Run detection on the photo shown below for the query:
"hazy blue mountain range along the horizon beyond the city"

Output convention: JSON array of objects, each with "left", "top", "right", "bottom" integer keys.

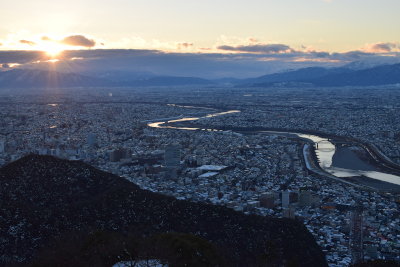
[{"left": 0, "top": 62, "right": 400, "bottom": 88}]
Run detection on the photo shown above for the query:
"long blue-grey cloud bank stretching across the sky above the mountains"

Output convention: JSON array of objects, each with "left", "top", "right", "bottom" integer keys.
[{"left": 0, "top": 45, "right": 400, "bottom": 78}]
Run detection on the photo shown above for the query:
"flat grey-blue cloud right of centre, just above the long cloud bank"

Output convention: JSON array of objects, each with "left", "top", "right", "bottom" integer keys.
[{"left": 217, "top": 44, "right": 295, "bottom": 54}]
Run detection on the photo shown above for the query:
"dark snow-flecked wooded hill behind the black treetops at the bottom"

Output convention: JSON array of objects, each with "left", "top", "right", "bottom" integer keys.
[{"left": 0, "top": 155, "right": 326, "bottom": 266}]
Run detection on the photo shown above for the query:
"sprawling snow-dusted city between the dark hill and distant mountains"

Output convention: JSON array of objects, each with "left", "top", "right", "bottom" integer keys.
[{"left": 0, "top": 86, "right": 400, "bottom": 266}]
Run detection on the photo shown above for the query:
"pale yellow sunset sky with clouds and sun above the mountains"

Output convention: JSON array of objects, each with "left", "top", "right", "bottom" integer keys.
[{"left": 0, "top": 0, "right": 400, "bottom": 78}]
